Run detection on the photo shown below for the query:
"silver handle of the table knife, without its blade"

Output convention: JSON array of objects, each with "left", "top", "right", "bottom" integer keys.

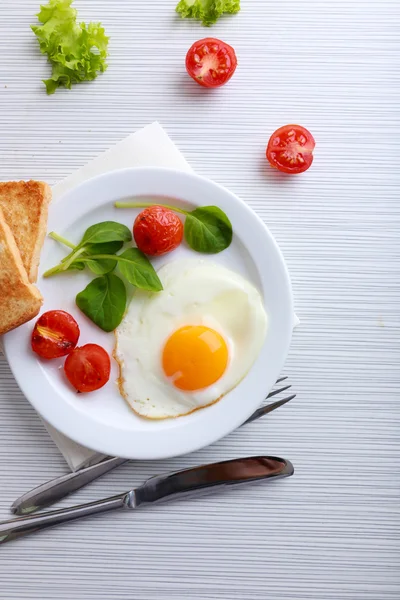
[{"left": 0, "top": 494, "right": 126, "bottom": 544}]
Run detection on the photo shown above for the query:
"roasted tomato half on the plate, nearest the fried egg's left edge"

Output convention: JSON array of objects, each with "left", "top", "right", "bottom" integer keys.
[{"left": 64, "top": 344, "right": 111, "bottom": 392}]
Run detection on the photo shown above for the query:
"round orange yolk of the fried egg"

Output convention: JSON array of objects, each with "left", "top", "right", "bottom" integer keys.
[{"left": 162, "top": 325, "right": 228, "bottom": 392}]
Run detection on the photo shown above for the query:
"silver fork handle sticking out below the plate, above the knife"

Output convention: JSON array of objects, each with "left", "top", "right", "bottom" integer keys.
[{"left": 11, "top": 458, "right": 127, "bottom": 515}]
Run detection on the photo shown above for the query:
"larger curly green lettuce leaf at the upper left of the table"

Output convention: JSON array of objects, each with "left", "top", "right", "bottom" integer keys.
[{"left": 31, "top": 0, "right": 108, "bottom": 94}]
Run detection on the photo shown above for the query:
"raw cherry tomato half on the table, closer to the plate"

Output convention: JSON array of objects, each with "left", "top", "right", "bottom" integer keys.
[{"left": 267, "top": 125, "right": 315, "bottom": 174}]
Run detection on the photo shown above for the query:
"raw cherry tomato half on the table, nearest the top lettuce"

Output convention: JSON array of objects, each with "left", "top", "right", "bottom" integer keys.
[{"left": 186, "top": 38, "right": 237, "bottom": 87}]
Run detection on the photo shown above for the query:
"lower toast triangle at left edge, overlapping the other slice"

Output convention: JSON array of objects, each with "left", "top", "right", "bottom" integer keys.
[{"left": 0, "top": 208, "right": 43, "bottom": 335}]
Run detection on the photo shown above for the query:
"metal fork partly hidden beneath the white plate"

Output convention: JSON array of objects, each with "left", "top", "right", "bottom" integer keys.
[{"left": 11, "top": 377, "right": 296, "bottom": 515}]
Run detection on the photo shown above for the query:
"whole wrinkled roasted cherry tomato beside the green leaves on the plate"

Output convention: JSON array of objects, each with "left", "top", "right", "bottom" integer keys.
[{"left": 133, "top": 205, "right": 183, "bottom": 256}]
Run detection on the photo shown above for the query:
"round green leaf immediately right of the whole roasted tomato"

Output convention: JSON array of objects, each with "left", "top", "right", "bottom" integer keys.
[{"left": 185, "top": 206, "right": 232, "bottom": 254}]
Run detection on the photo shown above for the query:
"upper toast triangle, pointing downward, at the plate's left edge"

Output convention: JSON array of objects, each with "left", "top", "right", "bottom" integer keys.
[{"left": 0, "top": 181, "right": 51, "bottom": 282}]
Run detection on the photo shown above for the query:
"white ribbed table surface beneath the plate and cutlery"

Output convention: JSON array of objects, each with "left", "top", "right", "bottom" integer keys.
[{"left": 0, "top": 0, "right": 400, "bottom": 600}]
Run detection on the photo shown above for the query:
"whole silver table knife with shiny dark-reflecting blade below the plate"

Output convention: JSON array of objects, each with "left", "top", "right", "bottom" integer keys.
[{"left": 0, "top": 456, "right": 294, "bottom": 544}]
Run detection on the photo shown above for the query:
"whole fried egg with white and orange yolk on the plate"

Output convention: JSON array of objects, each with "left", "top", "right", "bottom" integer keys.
[{"left": 114, "top": 259, "right": 268, "bottom": 419}]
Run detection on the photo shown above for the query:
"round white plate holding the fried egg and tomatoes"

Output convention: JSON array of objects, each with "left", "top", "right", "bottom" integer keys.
[{"left": 4, "top": 168, "right": 293, "bottom": 459}]
